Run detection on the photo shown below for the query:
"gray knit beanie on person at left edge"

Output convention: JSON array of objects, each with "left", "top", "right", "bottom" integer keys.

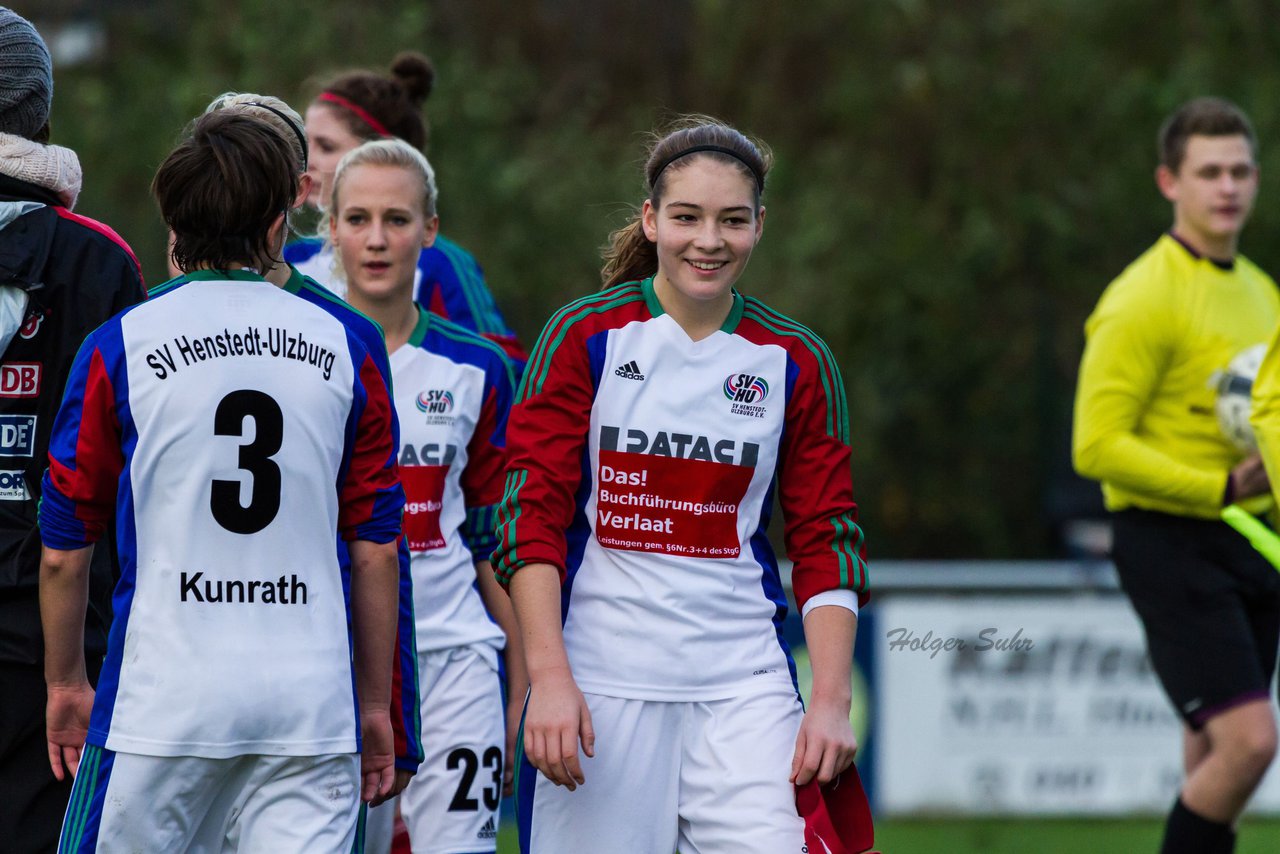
[{"left": 0, "top": 6, "right": 54, "bottom": 140}]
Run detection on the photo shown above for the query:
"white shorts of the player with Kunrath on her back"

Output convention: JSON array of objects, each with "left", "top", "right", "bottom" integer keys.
[{"left": 58, "top": 745, "right": 360, "bottom": 854}]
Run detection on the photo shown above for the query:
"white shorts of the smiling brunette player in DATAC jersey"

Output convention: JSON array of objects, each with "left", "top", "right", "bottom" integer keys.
[{"left": 516, "top": 693, "right": 805, "bottom": 854}]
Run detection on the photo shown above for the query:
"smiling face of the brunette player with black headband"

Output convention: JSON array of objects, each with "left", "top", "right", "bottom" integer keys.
[{"left": 641, "top": 155, "right": 764, "bottom": 311}]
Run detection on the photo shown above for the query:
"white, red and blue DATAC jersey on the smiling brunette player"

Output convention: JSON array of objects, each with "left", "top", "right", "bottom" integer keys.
[{"left": 494, "top": 280, "right": 867, "bottom": 700}]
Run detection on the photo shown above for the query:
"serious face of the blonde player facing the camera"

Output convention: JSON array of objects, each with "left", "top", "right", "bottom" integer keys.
[{"left": 329, "top": 164, "right": 439, "bottom": 301}]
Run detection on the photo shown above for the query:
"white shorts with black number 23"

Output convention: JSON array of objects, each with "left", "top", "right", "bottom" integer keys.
[{"left": 401, "top": 647, "right": 507, "bottom": 854}]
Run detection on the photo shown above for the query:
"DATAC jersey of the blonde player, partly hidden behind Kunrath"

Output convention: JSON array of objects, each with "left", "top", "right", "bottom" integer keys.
[{"left": 390, "top": 309, "right": 515, "bottom": 661}]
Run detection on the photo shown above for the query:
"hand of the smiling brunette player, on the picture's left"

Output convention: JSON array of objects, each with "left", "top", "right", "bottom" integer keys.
[{"left": 525, "top": 668, "right": 595, "bottom": 791}]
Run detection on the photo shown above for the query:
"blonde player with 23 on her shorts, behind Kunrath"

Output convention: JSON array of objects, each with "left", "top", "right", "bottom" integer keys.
[{"left": 328, "top": 140, "right": 526, "bottom": 854}]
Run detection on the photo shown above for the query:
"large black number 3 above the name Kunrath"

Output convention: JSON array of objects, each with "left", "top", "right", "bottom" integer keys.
[{"left": 209, "top": 388, "right": 284, "bottom": 534}]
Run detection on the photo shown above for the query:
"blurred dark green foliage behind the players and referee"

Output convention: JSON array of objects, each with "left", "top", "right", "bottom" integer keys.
[{"left": 40, "top": 0, "right": 1280, "bottom": 557}]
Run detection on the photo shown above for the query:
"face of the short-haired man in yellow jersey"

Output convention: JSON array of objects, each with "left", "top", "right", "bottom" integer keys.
[{"left": 1157, "top": 134, "right": 1258, "bottom": 259}]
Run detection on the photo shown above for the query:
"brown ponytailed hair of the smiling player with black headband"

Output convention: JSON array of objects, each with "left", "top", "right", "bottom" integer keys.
[{"left": 600, "top": 115, "right": 773, "bottom": 288}]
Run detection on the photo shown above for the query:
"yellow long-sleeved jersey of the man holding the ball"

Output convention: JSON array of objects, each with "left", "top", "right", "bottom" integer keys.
[{"left": 1071, "top": 234, "right": 1280, "bottom": 519}]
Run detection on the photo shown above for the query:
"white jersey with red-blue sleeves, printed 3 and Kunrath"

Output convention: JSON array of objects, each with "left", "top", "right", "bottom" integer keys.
[{"left": 40, "top": 271, "right": 403, "bottom": 758}]
